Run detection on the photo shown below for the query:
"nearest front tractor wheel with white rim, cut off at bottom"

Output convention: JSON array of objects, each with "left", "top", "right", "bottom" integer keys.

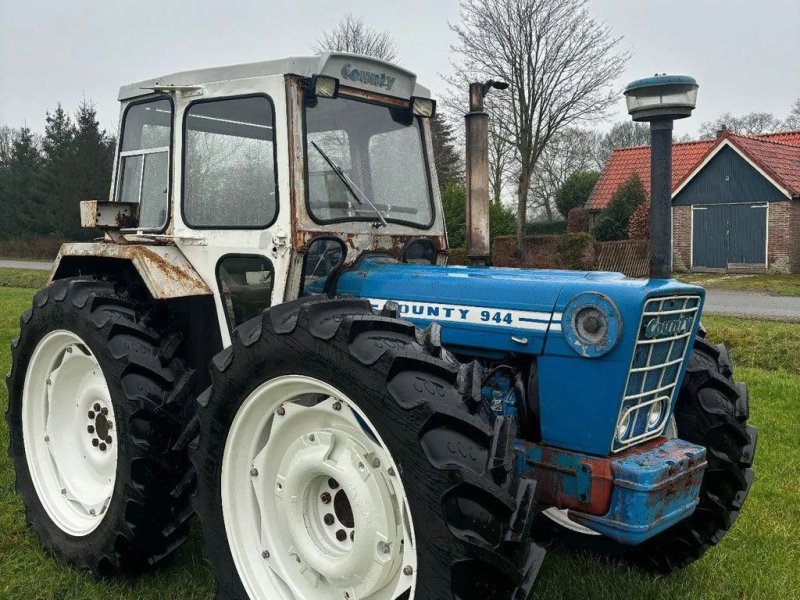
[{"left": 193, "top": 298, "right": 541, "bottom": 600}]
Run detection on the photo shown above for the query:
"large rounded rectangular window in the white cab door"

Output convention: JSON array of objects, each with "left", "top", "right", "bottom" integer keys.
[{"left": 183, "top": 97, "right": 277, "bottom": 229}]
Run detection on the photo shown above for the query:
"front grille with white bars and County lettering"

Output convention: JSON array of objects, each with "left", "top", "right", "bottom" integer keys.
[{"left": 611, "top": 296, "right": 700, "bottom": 452}]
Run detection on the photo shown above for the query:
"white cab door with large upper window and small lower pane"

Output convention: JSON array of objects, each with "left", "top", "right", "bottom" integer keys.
[{"left": 173, "top": 76, "right": 291, "bottom": 345}]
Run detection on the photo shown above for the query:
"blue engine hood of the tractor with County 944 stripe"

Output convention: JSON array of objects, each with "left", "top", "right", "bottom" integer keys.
[{"left": 337, "top": 256, "right": 705, "bottom": 456}]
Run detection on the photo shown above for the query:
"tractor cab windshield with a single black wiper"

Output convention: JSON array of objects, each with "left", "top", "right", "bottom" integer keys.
[{"left": 306, "top": 97, "right": 433, "bottom": 228}]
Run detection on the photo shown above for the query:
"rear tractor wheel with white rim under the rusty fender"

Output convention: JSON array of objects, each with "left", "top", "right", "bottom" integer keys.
[{"left": 6, "top": 278, "right": 193, "bottom": 576}]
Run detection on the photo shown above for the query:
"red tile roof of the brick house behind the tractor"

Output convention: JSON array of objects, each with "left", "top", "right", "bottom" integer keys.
[{"left": 586, "top": 131, "right": 800, "bottom": 210}]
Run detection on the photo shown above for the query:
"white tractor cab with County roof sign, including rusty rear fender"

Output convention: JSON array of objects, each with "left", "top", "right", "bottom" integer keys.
[{"left": 54, "top": 53, "right": 447, "bottom": 346}]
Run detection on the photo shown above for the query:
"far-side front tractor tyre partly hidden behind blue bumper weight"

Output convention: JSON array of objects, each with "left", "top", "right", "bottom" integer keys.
[{"left": 535, "top": 331, "right": 757, "bottom": 573}]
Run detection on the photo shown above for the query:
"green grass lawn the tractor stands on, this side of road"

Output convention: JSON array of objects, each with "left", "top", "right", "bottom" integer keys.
[{"left": 0, "top": 287, "right": 800, "bottom": 600}]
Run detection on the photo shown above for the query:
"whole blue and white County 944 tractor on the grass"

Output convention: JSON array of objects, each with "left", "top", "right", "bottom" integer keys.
[{"left": 6, "top": 53, "right": 756, "bottom": 600}]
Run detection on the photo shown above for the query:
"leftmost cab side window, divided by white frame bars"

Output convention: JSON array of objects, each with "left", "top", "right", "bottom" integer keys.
[{"left": 117, "top": 99, "right": 172, "bottom": 229}]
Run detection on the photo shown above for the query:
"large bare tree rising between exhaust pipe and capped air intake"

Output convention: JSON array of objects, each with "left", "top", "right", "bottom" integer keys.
[{"left": 451, "top": 0, "right": 628, "bottom": 248}]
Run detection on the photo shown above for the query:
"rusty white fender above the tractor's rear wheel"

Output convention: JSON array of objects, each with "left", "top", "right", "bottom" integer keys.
[{"left": 50, "top": 242, "right": 212, "bottom": 300}]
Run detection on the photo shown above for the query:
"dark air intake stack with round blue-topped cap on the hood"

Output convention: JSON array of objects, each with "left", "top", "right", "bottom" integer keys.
[{"left": 625, "top": 75, "right": 699, "bottom": 279}]
